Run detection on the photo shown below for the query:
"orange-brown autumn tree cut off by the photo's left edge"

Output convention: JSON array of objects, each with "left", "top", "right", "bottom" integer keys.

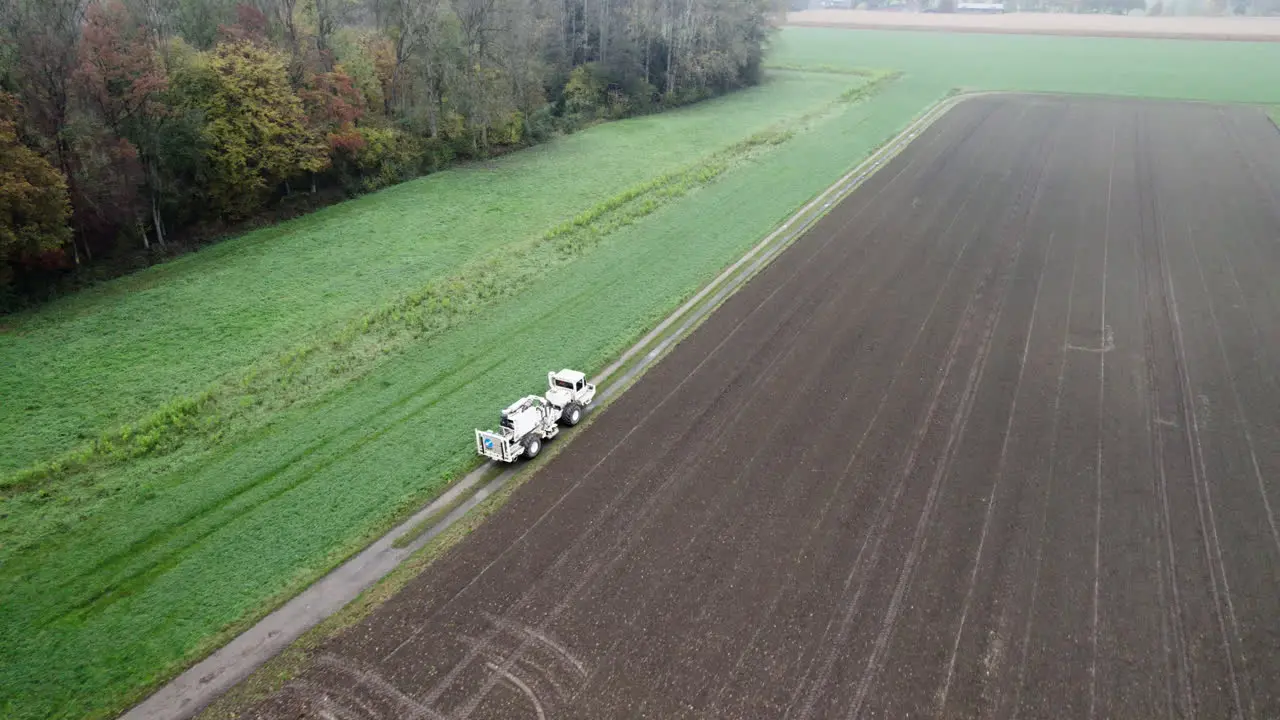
[{"left": 0, "top": 92, "right": 72, "bottom": 288}]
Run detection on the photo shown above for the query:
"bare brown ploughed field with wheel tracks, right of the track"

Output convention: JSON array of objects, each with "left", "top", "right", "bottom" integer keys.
[{"left": 240, "top": 96, "right": 1280, "bottom": 719}]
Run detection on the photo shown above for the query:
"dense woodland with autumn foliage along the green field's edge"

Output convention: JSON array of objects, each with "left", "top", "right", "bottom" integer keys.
[{"left": 0, "top": 0, "right": 771, "bottom": 309}]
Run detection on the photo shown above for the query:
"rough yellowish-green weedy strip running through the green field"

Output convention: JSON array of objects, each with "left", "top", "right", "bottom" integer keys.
[{"left": 0, "top": 70, "right": 897, "bottom": 497}]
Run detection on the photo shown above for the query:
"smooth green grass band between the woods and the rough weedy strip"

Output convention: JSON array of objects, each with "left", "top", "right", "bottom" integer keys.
[{"left": 0, "top": 67, "right": 849, "bottom": 475}]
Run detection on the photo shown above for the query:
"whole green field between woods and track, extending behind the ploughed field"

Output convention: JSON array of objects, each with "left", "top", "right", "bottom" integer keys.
[{"left": 0, "top": 29, "right": 1280, "bottom": 719}]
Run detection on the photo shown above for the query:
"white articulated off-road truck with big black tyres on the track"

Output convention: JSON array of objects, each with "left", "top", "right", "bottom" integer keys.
[{"left": 476, "top": 369, "right": 595, "bottom": 462}]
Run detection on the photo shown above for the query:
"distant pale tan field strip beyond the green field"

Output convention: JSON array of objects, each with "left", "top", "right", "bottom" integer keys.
[{"left": 786, "top": 10, "right": 1280, "bottom": 42}]
